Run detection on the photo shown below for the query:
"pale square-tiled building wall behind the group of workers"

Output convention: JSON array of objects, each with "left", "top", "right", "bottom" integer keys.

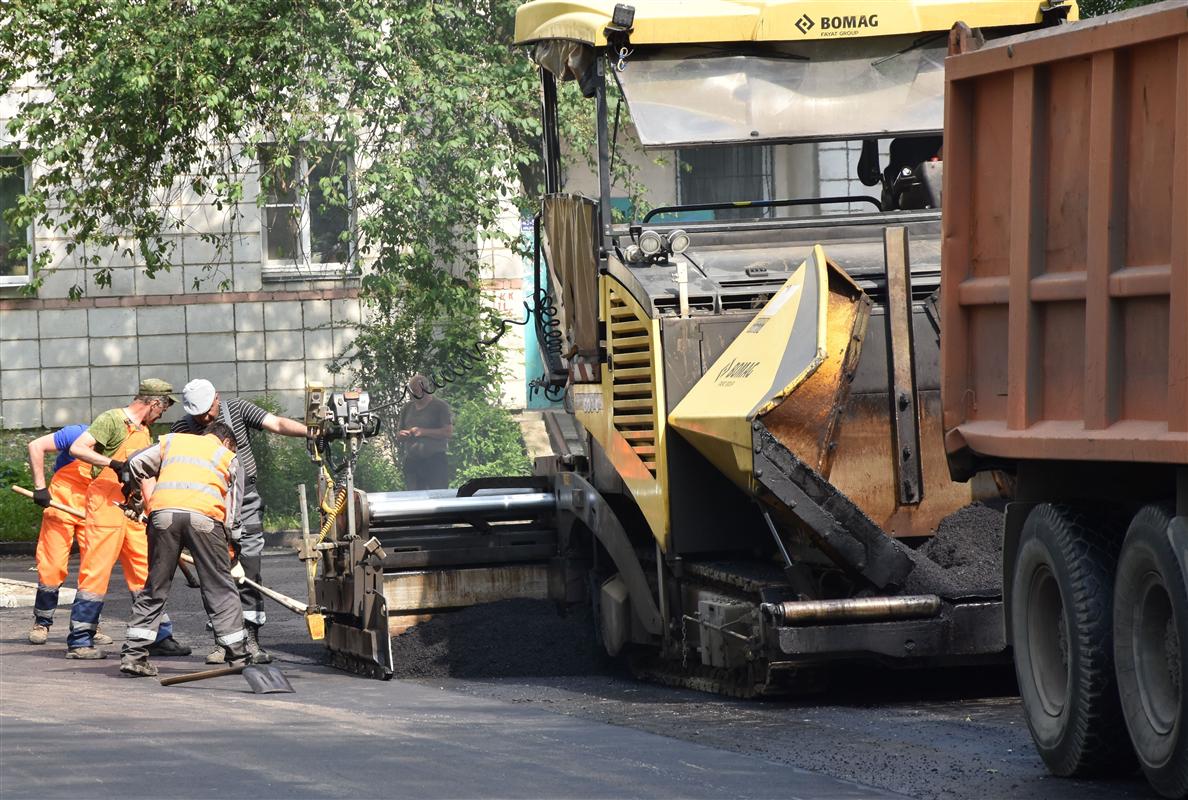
[{"left": 0, "top": 101, "right": 539, "bottom": 428}]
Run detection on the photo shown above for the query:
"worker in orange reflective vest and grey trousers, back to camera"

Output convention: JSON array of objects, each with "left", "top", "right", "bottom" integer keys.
[{"left": 120, "top": 422, "right": 248, "bottom": 676}]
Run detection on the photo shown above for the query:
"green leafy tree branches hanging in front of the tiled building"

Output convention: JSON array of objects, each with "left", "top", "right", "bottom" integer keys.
[{"left": 0, "top": 0, "right": 651, "bottom": 487}]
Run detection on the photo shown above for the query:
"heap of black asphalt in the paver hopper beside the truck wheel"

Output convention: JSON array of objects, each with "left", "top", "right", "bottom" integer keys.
[{"left": 903, "top": 503, "right": 1003, "bottom": 598}]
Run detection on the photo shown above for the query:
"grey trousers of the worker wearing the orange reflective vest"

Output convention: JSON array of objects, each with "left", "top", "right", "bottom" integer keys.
[{"left": 122, "top": 510, "right": 247, "bottom": 659}]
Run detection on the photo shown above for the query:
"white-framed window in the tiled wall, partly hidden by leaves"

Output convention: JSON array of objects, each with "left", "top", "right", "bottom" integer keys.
[{"left": 260, "top": 147, "right": 354, "bottom": 278}]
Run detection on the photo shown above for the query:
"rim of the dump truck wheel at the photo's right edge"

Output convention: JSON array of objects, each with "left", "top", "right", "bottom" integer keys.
[{"left": 1133, "top": 573, "right": 1183, "bottom": 736}]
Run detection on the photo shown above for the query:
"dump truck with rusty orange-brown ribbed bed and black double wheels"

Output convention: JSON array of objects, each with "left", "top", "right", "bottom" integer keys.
[{"left": 941, "top": 2, "right": 1188, "bottom": 798}]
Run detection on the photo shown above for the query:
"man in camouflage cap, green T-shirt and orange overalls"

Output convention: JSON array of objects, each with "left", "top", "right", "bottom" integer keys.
[{"left": 67, "top": 378, "right": 190, "bottom": 660}]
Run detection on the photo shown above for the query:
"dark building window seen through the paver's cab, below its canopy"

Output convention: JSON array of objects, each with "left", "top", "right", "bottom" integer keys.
[{"left": 676, "top": 145, "right": 772, "bottom": 220}]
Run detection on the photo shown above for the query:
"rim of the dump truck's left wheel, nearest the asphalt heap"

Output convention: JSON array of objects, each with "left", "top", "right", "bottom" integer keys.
[{"left": 1028, "top": 566, "right": 1068, "bottom": 717}]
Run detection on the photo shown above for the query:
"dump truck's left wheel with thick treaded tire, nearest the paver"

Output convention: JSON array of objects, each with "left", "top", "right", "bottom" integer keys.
[{"left": 1011, "top": 503, "right": 1135, "bottom": 777}]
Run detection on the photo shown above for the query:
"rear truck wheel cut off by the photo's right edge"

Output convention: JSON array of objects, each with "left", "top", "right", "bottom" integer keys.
[{"left": 1114, "top": 505, "right": 1188, "bottom": 798}]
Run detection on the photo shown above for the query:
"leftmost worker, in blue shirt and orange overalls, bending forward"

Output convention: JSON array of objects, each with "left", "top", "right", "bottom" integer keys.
[{"left": 29, "top": 426, "right": 99, "bottom": 644}]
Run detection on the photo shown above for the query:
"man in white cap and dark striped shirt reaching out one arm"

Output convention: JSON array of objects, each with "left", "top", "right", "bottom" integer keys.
[{"left": 172, "top": 378, "right": 309, "bottom": 663}]
